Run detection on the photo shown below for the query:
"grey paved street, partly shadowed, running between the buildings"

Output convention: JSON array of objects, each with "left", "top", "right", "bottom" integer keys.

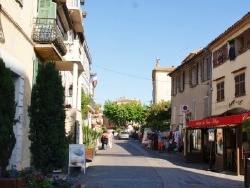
[{"left": 79, "top": 139, "right": 244, "bottom": 188}]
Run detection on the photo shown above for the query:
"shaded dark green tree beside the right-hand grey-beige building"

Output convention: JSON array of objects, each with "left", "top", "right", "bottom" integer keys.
[{"left": 145, "top": 101, "right": 171, "bottom": 131}]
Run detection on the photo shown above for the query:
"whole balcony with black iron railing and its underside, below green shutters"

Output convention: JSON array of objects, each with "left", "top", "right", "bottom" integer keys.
[{"left": 32, "top": 18, "right": 67, "bottom": 61}]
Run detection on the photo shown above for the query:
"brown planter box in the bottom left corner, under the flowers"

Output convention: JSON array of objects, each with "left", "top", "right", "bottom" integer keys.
[{"left": 0, "top": 178, "right": 26, "bottom": 188}]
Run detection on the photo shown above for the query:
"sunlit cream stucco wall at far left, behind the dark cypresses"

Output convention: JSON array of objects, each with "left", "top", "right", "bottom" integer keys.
[{"left": 0, "top": 0, "right": 36, "bottom": 168}]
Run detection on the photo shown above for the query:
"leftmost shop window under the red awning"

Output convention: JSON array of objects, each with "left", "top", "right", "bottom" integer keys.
[{"left": 188, "top": 129, "right": 201, "bottom": 152}]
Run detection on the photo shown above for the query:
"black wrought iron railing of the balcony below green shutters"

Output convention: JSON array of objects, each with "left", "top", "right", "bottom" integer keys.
[{"left": 32, "top": 18, "right": 67, "bottom": 56}]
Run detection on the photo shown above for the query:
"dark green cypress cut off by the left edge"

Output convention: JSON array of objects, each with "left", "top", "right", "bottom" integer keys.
[{"left": 0, "top": 58, "right": 16, "bottom": 175}]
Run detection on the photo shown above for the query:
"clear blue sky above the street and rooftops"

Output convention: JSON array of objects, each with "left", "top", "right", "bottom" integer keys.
[{"left": 83, "top": 0, "right": 250, "bottom": 107}]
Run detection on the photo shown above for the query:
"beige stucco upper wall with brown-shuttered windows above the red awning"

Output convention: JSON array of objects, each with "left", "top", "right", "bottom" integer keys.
[{"left": 212, "top": 23, "right": 250, "bottom": 115}]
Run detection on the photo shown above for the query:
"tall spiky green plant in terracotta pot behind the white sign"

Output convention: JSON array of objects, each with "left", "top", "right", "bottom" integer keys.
[{"left": 82, "top": 126, "right": 101, "bottom": 161}]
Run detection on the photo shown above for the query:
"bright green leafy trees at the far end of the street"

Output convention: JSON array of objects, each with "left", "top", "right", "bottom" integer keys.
[{"left": 103, "top": 101, "right": 146, "bottom": 126}]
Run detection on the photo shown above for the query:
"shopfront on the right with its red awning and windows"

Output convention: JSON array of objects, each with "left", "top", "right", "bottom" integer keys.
[{"left": 186, "top": 113, "right": 250, "bottom": 175}]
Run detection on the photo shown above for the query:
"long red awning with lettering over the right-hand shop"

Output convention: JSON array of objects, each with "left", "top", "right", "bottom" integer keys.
[{"left": 188, "top": 113, "right": 250, "bottom": 128}]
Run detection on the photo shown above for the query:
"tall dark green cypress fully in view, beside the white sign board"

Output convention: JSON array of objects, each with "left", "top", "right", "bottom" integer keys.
[{"left": 28, "top": 62, "right": 68, "bottom": 174}]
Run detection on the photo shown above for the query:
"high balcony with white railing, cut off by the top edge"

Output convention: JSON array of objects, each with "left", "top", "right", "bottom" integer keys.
[{"left": 67, "top": 0, "right": 84, "bottom": 33}]
